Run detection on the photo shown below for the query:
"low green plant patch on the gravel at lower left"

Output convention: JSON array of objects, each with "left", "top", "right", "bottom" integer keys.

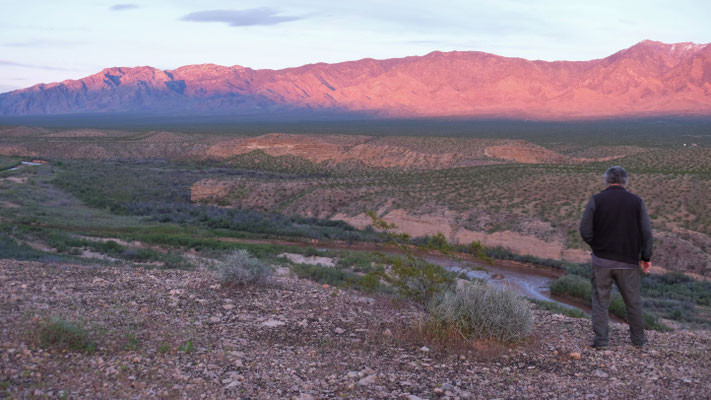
[{"left": 38, "top": 317, "right": 96, "bottom": 353}]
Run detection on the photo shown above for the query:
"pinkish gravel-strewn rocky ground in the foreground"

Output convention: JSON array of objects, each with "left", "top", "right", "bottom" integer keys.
[{"left": 0, "top": 260, "right": 711, "bottom": 399}]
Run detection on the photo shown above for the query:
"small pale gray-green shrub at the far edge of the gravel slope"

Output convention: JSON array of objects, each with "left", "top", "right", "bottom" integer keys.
[{"left": 218, "top": 250, "right": 274, "bottom": 286}]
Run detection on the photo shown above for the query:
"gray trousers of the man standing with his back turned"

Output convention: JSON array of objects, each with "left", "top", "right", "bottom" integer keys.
[{"left": 591, "top": 267, "right": 647, "bottom": 346}]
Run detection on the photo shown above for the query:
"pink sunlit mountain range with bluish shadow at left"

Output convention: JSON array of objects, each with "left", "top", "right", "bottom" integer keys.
[{"left": 0, "top": 40, "right": 711, "bottom": 120}]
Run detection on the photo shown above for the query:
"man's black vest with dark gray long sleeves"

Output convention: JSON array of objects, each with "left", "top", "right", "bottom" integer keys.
[{"left": 580, "top": 186, "right": 653, "bottom": 264}]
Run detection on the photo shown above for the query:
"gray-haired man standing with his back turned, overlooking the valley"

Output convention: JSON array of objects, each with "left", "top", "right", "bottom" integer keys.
[{"left": 580, "top": 166, "right": 652, "bottom": 349}]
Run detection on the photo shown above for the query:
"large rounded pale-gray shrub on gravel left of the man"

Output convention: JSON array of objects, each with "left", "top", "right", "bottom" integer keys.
[{"left": 427, "top": 283, "right": 533, "bottom": 342}]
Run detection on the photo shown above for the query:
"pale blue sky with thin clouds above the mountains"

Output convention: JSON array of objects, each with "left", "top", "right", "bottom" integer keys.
[{"left": 0, "top": 0, "right": 711, "bottom": 92}]
